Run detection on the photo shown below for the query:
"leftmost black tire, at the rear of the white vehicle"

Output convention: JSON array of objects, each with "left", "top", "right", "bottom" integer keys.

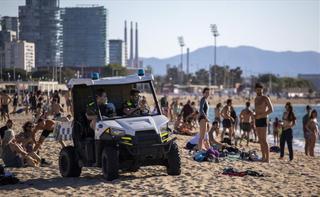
[{"left": 59, "top": 146, "right": 81, "bottom": 177}]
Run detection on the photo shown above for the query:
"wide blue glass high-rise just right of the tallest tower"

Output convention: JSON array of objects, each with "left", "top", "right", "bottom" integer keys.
[{"left": 61, "top": 6, "right": 107, "bottom": 67}]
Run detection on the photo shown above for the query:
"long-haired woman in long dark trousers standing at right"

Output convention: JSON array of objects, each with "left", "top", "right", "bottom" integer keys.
[{"left": 280, "top": 102, "right": 296, "bottom": 161}]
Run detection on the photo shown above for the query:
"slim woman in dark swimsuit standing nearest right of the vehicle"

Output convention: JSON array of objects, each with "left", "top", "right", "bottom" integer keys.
[{"left": 198, "top": 88, "right": 210, "bottom": 150}]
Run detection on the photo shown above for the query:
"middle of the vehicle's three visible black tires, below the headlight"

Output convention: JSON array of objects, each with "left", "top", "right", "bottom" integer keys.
[{"left": 101, "top": 146, "right": 119, "bottom": 181}]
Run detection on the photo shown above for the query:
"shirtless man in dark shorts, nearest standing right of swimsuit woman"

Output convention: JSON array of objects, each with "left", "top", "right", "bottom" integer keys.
[{"left": 221, "top": 99, "right": 234, "bottom": 141}]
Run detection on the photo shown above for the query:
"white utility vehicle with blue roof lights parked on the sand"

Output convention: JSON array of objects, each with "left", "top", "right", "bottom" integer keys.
[{"left": 59, "top": 70, "right": 181, "bottom": 180}]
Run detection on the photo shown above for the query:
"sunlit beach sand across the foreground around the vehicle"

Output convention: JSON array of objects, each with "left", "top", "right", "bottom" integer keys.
[{"left": 0, "top": 111, "right": 320, "bottom": 196}]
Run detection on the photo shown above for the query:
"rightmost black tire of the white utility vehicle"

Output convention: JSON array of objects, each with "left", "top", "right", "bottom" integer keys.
[{"left": 167, "top": 142, "right": 181, "bottom": 176}]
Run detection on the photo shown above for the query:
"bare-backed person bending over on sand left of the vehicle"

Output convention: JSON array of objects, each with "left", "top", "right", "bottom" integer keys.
[{"left": 33, "top": 118, "right": 65, "bottom": 152}]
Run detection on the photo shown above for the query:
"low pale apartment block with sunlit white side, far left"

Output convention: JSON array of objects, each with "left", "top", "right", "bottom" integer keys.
[{"left": 4, "top": 41, "right": 35, "bottom": 72}]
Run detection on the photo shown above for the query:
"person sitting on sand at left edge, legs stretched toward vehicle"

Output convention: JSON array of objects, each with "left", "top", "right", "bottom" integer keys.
[{"left": 2, "top": 129, "right": 39, "bottom": 168}]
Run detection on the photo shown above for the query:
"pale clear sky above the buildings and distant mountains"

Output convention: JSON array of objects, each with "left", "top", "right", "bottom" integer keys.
[{"left": 0, "top": 0, "right": 320, "bottom": 58}]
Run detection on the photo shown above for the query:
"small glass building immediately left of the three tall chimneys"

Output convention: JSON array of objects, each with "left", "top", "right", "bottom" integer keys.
[{"left": 109, "top": 40, "right": 126, "bottom": 66}]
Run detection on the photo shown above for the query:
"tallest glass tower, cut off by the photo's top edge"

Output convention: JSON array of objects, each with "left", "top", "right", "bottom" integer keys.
[{"left": 19, "top": 0, "right": 62, "bottom": 67}]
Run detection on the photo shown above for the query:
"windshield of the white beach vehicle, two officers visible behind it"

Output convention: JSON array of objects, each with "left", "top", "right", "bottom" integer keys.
[{"left": 94, "top": 82, "right": 160, "bottom": 120}]
